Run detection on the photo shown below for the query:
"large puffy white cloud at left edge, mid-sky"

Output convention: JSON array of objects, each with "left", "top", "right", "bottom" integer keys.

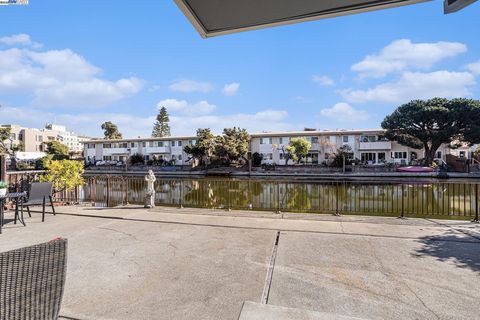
[{"left": 0, "top": 40, "right": 144, "bottom": 107}]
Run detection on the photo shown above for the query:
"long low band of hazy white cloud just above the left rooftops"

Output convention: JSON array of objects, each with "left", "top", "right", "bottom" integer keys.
[{"left": 0, "top": 107, "right": 294, "bottom": 138}]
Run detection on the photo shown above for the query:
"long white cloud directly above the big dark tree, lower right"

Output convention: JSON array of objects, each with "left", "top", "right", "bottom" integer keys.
[{"left": 340, "top": 71, "right": 476, "bottom": 103}]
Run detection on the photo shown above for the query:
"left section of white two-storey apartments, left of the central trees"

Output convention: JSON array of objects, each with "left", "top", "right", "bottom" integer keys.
[{"left": 84, "top": 136, "right": 196, "bottom": 165}]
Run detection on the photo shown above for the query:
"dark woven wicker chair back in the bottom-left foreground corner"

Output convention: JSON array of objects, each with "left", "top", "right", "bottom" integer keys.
[{"left": 0, "top": 239, "right": 67, "bottom": 320}]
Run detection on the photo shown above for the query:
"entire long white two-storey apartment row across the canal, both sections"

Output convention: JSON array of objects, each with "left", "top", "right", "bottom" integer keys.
[{"left": 84, "top": 129, "right": 470, "bottom": 165}]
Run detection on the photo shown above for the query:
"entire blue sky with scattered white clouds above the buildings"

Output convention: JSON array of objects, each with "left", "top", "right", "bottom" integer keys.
[{"left": 0, "top": 0, "right": 480, "bottom": 137}]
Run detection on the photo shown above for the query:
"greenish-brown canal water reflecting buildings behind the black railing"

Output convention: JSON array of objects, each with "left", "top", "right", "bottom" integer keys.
[{"left": 79, "top": 176, "right": 480, "bottom": 219}]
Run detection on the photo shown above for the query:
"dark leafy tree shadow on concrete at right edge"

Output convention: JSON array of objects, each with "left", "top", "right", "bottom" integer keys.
[{"left": 413, "top": 233, "right": 480, "bottom": 273}]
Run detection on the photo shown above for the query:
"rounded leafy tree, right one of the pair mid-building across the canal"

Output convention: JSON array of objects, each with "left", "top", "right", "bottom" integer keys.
[{"left": 215, "top": 127, "right": 250, "bottom": 164}]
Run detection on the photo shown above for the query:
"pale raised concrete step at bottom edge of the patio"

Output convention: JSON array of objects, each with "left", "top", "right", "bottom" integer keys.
[{"left": 239, "top": 301, "right": 365, "bottom": 320}]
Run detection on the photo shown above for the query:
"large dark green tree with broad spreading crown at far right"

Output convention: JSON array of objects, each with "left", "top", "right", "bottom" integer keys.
[{"left": 382, "top": 98, "right": 480, "bottom": 165}]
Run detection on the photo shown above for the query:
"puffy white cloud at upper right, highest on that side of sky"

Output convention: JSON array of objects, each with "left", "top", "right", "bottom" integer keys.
[{"left": 351, "top": 39, "right": 467, "bottom": 78}]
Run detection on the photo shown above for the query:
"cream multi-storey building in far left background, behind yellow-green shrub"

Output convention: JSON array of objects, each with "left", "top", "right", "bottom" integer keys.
[{"left": 1, "top": 124, "right": 91, "bottom": 152}]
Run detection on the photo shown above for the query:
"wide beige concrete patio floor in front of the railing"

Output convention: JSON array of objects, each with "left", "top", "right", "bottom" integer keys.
[{"left": 0, "top": 207, "right": 480, "bottom": 320}]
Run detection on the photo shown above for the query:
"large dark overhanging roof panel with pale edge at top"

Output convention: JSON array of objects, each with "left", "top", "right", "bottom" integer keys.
[{"left": 175, "top": 0, "right": 431, "bottom": 38}]
